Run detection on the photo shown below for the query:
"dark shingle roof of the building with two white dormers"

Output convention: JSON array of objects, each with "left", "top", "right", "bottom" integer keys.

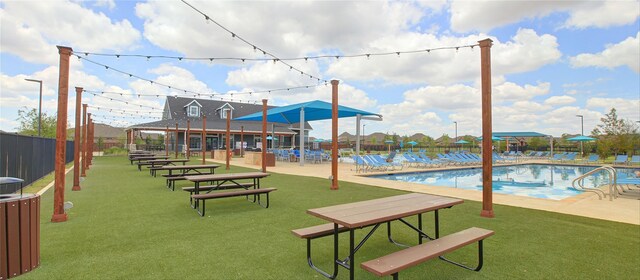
[{"left": 129, "top": 97, "right": 311, "bottom": 133}]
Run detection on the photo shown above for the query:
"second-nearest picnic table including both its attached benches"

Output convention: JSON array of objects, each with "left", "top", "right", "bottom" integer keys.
[{"left": 185, "top": 172, "right": 275, "bottom": 216}]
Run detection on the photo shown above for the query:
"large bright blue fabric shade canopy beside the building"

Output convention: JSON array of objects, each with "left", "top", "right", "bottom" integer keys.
[{"left": 234, "top": 100, "right": 379, "bottom": 124}]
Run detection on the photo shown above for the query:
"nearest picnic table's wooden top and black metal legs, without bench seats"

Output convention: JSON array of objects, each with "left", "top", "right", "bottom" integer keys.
[{"left": 307, "top": 193, "right": 463, "bottom": 279}]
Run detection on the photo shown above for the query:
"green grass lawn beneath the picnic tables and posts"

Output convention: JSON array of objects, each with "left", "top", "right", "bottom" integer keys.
[{"left": 21, "top": 157, "right": 640, "bottom": 279}]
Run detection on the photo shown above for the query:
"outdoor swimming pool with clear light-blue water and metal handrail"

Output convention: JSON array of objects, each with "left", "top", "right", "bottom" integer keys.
[{"left": 372, "top": 164, "right": 632, "bottom": 200}]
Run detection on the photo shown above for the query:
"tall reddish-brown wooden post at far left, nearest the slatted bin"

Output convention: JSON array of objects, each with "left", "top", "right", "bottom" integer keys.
[{"left": 51, "top": 46, "right": 73, "bottom": 222}]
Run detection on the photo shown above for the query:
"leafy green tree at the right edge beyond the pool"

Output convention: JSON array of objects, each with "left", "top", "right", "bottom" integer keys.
[{"left": 591, "top": 108, "right": 640, "bottom": 158}]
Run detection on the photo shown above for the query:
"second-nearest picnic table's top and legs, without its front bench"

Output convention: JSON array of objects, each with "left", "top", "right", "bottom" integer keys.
[{"left": 185, "top": 172, "right": 269, "bottom": 208}]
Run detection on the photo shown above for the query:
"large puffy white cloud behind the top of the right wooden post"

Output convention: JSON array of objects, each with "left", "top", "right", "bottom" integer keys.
[{"left": 327, "top": 29, "right": 561, "bottom": 85}]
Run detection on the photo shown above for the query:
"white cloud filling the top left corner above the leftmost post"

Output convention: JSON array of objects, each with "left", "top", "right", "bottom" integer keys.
[{"left": 0, "top": 1, "right": 140, "bottom": 65}]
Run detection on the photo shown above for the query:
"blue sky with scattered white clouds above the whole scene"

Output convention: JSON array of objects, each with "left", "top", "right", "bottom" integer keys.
[{"left": 0, "top": 0, "right": 640, "bottom": 138}]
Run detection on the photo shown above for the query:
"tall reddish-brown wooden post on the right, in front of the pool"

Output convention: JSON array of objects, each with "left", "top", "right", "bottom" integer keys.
[{"left": 478, "top": 39, "right": 494, "bottom": 218}]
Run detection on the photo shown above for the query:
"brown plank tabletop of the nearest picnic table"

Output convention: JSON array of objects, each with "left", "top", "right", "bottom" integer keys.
[{"left": 307, "top": 193, "right": 463, "bottom": 228}]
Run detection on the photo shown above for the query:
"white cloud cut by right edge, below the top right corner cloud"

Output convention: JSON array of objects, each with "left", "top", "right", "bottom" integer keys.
[{"left": 571, "top": 32, "right": 640, "bottom": 73}]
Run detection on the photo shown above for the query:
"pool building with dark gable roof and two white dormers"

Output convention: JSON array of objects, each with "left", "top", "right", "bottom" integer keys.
[{"left": 126, "top": 97, "right": 312, "bottom": 151}]
